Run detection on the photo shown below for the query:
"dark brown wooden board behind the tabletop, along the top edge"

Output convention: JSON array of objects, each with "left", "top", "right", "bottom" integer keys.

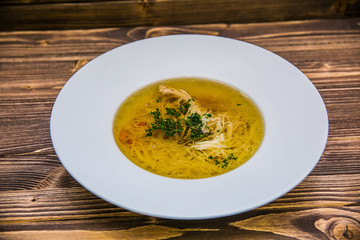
[{"left": 0, "top": 0, "right": 359, "bottom": 31}]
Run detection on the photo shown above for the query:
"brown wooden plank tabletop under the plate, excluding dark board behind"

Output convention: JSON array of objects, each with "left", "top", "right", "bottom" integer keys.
[{"left": 0, "top": 18, "right": 360, "bottom": 240}]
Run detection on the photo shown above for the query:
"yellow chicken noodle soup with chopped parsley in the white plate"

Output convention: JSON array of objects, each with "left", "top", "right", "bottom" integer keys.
[{"left": 113, "top": 78, "right": 265, "bottom": 179}]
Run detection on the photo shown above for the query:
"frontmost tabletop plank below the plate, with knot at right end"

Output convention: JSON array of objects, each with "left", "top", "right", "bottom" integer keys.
[{"left": 0, "top": 183, "right": 360, "bottom": 239}]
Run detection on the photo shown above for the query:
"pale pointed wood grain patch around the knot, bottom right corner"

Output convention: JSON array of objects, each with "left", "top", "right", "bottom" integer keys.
[{"left": 231, "top": 208, "right": 360, "bottom": 240}]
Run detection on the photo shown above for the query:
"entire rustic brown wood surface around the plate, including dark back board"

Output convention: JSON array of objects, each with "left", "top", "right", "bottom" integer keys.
[{"left": 0, "top": 0, "right": 360, "bottom": 240}]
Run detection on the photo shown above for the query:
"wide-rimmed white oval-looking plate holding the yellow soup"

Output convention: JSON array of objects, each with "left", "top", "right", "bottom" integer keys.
[{"left": 50, "top": 35, "right": 328, "bottom": 219}]
